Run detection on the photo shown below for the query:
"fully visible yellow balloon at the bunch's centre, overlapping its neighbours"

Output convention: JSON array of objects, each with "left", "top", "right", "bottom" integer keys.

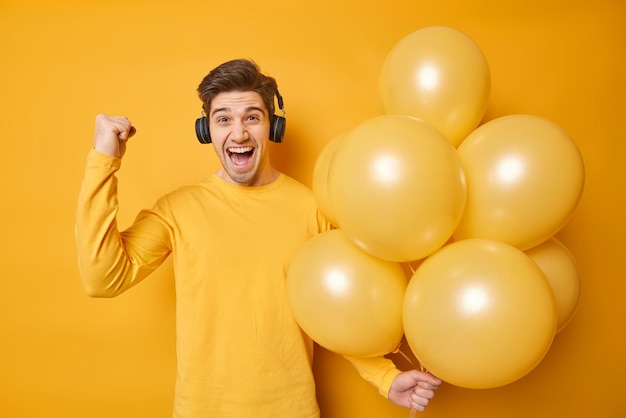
[{"left": 328, "top": 115, "right": 465, "bottom": 262}]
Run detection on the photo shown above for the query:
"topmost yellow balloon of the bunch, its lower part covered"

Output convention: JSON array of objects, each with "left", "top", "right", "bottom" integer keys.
[{"left": 379, "top": 26, "right": 491, "bottom": 146}]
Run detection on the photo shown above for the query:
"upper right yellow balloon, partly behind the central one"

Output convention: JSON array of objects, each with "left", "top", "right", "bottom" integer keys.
[{"left": 454, "top": 115, "right": 585, "bottom": 250}]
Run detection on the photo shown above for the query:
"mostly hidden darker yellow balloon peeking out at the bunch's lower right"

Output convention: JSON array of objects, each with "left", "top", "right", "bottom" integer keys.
[{"left": 526, "top": 237, "right": 581, "bottom": 333}]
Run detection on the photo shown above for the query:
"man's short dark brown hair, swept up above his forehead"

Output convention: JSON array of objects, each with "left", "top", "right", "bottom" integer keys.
[{"left": 198, "top": 59, "right": 278, "bottom": 117}]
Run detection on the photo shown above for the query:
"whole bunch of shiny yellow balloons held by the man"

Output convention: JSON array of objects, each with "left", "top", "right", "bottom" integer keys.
[{"left": 287, "top": 26, "right": 584, "bottom": 388}]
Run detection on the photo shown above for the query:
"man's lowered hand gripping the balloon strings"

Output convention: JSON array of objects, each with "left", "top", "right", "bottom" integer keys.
[{"left": 389, "top": 370, "right": 441, "bottom": 412}]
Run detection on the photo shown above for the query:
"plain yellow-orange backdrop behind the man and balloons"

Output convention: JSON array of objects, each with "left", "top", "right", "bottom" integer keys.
[{"left": 0, "top": 0, "right": 626, "bottom": 418}]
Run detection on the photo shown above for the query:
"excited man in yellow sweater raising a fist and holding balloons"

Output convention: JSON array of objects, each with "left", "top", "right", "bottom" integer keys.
[{"left": 76, "top": 60, "right": 441, "bottom": 418}]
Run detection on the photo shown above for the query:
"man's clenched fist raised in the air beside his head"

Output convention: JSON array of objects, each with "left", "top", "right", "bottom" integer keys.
[{"left": 93, "top": 114, "right": 136, "bottom": 158}]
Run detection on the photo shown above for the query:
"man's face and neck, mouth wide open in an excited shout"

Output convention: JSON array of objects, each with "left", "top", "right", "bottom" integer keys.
[{"left": 207, "top": 91, "right": 277, "bottom": 186}]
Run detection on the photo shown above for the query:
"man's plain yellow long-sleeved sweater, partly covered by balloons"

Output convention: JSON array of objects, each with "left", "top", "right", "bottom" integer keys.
[{"left": 76, "top": 150, "right": 399, "bottom": 418}]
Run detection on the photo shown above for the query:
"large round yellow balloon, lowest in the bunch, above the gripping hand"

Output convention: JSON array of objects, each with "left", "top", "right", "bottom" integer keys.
[{"left": 403, "top": 239, "right": 557, "bottom": 389}]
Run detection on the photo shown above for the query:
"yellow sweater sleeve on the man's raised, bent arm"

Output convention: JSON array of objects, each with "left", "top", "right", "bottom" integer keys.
[{"left": 75, "top": 149, "right": 171, "bottom": 297}]
